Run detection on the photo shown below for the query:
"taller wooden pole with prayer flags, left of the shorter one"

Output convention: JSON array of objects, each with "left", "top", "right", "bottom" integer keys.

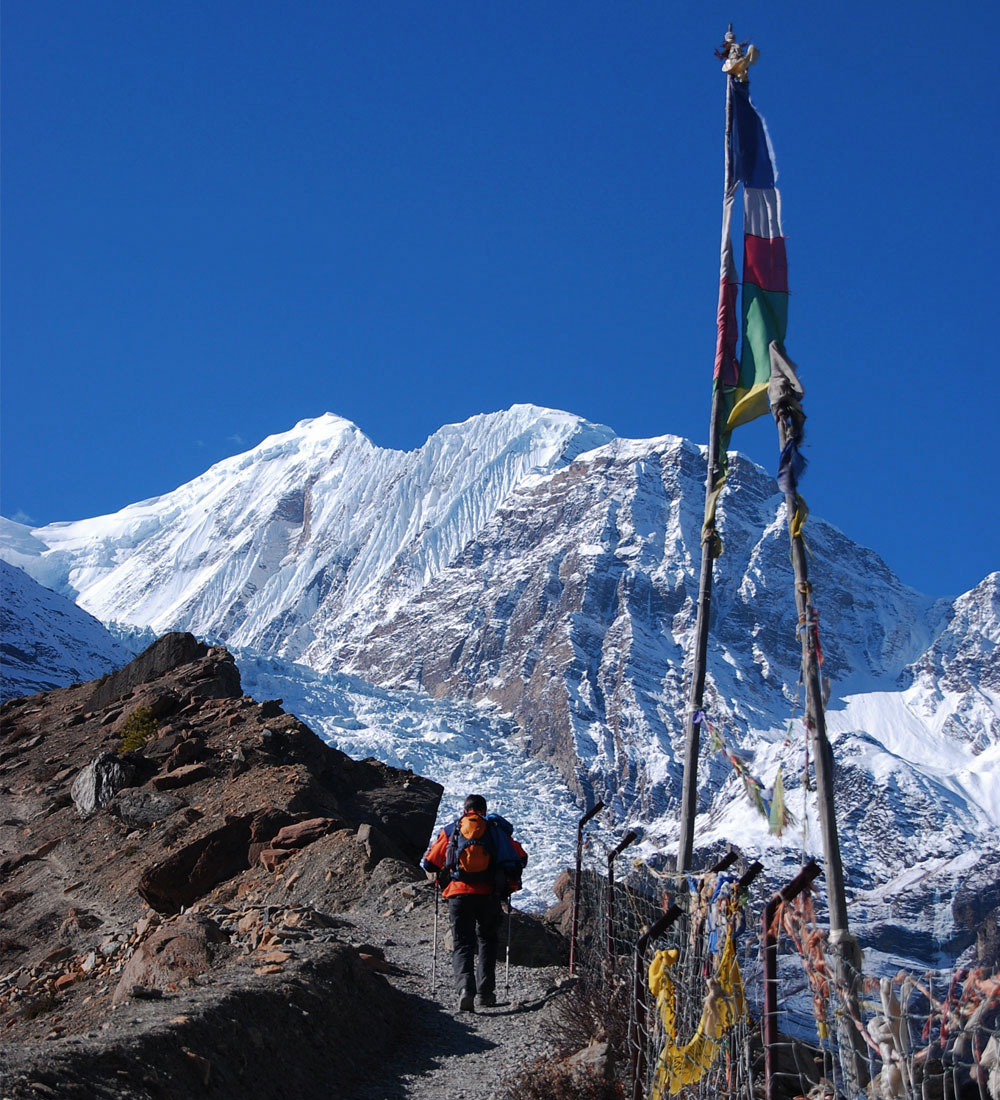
[{"left": 677, "top": 76, "right": 736, "bottom": 871}]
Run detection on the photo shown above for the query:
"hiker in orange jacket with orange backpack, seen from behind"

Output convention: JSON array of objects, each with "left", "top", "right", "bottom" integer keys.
[{"left": 420, "top": 794, "right": 528, "bottom": 1012}]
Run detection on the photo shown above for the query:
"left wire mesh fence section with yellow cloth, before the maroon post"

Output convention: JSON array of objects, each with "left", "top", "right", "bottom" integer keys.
[{"left": 578, "top": 840, "right": 759, "bottom": 1100}]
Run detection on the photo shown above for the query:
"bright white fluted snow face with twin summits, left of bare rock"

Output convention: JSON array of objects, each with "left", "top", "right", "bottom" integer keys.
[{"left": 4, "top": 405, "right": 614, "bottom": 657}]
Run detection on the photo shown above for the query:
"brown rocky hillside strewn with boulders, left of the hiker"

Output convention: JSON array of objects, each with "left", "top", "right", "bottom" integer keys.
[{"left": 0, "top": 635, "right": 441, "bottom": 1098}]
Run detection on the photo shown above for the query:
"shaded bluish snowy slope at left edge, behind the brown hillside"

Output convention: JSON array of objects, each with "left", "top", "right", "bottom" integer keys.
[{"left": 0, "top": 560, "right": 133, "bottom": 701}]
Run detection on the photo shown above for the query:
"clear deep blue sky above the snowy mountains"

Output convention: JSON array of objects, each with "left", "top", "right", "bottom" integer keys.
[{"left": 2, "top": 0, "right": 1000, "bottom": 598}]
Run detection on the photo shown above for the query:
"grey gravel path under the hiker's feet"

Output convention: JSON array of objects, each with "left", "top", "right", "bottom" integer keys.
[{"left": 350, "top": 889, "right": 569, "bottom": 1100}]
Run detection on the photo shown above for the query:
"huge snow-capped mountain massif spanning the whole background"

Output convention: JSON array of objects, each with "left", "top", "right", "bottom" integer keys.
[{"left": 0, "top": 406, "right": 1000, "bottom": 959}]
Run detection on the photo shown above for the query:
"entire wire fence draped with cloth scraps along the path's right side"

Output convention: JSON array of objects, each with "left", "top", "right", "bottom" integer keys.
[{"left": 575, "top": 838, "right": 1000, "bottom": 1100}]
